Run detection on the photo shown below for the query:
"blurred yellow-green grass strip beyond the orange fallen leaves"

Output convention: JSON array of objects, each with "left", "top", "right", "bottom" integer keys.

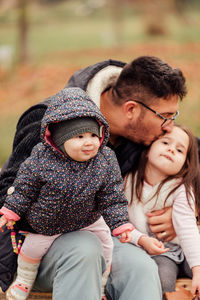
[{"left": 0, "top": 0, "right": 200, "bottom": 63}]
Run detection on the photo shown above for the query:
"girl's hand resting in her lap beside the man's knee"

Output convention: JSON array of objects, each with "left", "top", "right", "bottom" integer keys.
[{"left": 138, "top": 235, "right": 169, "bottom": 255}]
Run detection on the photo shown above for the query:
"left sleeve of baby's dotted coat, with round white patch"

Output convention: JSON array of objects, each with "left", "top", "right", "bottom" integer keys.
[{"left": 4, "top": 143, "right": 44, "bottom": 217}]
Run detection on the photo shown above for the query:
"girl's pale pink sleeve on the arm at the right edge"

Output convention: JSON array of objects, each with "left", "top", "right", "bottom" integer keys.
[{"left": 172, "top": 185, "right": 200, "bottom": 268}]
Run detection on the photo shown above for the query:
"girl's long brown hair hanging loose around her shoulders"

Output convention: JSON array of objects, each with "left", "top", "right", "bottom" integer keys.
[{"left": 124, "top": 124, "right": 200, "bottom": 217}]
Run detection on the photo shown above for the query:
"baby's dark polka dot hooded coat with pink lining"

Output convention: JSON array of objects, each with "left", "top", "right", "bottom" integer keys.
[{"left": 1, "top": 88, "right": 128, "bottom": 235}]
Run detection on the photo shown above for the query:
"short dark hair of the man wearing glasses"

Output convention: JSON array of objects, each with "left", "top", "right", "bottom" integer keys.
[{"left": 112, "top": 56, "right": 187, "bottom": 105}]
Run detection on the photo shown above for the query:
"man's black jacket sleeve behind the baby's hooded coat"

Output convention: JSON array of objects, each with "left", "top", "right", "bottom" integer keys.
[{"left": 0, "top": 104, "right": 47, "bottom": 207}]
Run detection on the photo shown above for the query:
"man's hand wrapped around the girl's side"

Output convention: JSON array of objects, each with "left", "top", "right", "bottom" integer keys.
[{"left": 146, "top": 206, "right": 176, "bottom": 242}]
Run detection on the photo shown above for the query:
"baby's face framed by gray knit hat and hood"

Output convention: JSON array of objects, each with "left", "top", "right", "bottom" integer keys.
[{"left": 64, "top": 132, "right": 100, "bottom": 162}]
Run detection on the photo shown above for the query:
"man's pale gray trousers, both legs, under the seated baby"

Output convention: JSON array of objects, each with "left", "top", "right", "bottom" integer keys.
[{"left": 35, "top": 231, "right": 162, "bottom": 300}]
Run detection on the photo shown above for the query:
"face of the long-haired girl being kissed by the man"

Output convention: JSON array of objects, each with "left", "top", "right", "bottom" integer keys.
[{"left": 146, "top": 126, "right": 189, "bottom": 180}]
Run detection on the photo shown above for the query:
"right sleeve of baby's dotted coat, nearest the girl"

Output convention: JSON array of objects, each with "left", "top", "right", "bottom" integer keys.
[{"left": 97, "top": 147, "right": 129, "bottom": 231}]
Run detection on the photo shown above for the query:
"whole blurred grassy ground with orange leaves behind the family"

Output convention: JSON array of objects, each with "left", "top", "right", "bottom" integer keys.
[{"left": 0, "top": 0, "right": 200, "bottom": 166}]
